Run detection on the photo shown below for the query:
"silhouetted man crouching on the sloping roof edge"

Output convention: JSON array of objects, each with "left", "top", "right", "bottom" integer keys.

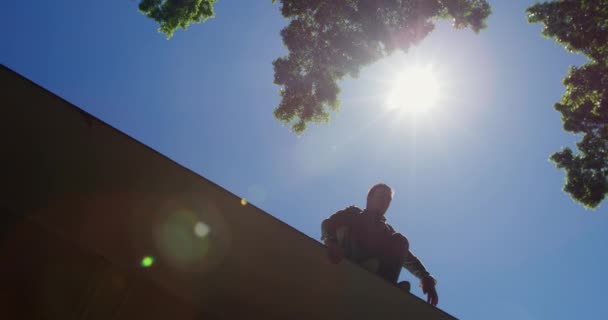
[{"left": 321, "top": 183, "right": 439, "bottom": 306}]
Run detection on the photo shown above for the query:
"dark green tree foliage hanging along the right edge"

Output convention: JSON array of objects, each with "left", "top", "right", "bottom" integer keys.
[{"left": 527, "top": 0, "right": 608, "bottom": 208}]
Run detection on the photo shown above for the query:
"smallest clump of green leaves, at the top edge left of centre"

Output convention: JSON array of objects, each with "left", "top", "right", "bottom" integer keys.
[{"left": 139, "top": 0, "right": 216, "bottom": 38}]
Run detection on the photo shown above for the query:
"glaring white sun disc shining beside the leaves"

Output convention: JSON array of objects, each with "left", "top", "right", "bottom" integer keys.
[{"left": 386, "top": 65, "right": 440, "bottom": 113}]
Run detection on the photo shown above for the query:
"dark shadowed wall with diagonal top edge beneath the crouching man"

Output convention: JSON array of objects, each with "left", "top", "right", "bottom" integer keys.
[{"left": 0, "top": 67, "right": 453, "bottom": 320}]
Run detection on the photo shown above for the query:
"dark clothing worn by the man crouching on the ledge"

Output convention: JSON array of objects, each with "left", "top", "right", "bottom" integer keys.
[{"left": 321, "top": 206, "right": 430, "bottom": 283}]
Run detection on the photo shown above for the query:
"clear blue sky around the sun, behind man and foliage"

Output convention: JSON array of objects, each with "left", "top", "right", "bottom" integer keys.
[{"left": 0, "top": 0, "right": 608, "bottom": 320}]
